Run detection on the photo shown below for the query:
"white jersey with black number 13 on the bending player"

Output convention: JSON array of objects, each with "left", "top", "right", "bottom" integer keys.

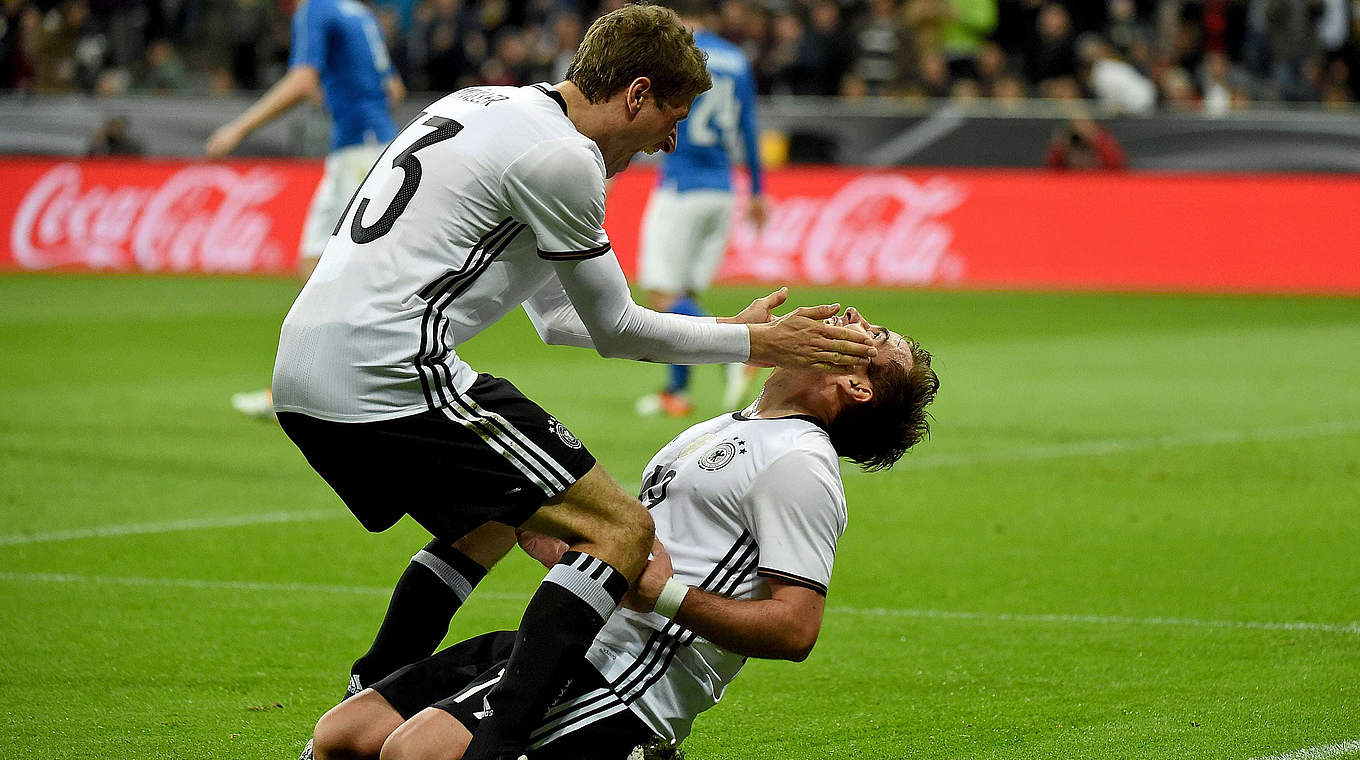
[{"left": 273, "top": 86, "right": 609, "bottom": 421}]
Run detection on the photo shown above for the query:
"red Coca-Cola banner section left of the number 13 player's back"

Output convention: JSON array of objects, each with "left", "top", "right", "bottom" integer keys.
[{"left": 0, "top": 158, "right": 321, "bottom": 273}]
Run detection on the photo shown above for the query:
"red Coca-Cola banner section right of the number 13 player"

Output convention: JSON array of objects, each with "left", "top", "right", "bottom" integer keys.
[{"left": 607, "top": 167, "right": 1360, "bottom": 294}]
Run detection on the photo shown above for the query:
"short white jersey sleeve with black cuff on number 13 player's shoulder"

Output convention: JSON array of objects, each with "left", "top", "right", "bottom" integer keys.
[{"left": 500, "top": 137, "right": 609, "bottom": 261}]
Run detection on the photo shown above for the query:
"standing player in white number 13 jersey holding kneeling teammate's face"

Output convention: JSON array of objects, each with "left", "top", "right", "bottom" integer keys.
[{"left": 273, "top": 5, "right": 877, "bottom": 760}]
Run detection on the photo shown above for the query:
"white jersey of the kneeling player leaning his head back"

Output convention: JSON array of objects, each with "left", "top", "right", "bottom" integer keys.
[{"left": 540, "top": 412, "right": 846, "bottom": 742}]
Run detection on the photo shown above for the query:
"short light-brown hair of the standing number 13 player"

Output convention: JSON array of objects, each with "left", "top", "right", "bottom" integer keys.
[{"left": 567, "top": 4, "right": 713, "bottom": 106}]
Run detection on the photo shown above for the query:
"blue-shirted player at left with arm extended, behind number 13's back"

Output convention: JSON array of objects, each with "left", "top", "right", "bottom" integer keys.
[{"left": 205, "top": 0, "right": 405, "bottom": 419}]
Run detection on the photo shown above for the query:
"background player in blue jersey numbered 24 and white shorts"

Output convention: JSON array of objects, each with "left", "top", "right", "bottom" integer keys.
[{"left": 636, "top": 0, "right": 766, "bottom": 417}]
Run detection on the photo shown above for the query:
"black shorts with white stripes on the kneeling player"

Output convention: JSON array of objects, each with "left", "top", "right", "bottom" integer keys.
[{"left": 373, "top": 631, "right": 656, "bottom": 760}]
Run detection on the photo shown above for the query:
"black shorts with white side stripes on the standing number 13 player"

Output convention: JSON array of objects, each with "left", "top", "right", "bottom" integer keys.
[{"left": 279, "top": 374, "right": 596, "bottom": 540}]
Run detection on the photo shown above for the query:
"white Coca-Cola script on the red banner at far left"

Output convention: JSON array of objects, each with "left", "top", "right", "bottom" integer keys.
[{"left": 10, "top": 163, "right": 288, "bottom": 272}]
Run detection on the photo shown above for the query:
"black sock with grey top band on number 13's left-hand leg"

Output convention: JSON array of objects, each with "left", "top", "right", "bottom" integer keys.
[{"left": 350, "top": 538, "right": 487, "bottom": 692}]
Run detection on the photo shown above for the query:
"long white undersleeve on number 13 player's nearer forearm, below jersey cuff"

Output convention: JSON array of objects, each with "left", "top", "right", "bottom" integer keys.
[{"left": 552, "top": 250, "right": 751, "bottom": 364}]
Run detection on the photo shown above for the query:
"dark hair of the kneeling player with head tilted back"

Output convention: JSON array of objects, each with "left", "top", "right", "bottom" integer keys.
[{"left": 831, "top": 339, "right": 940, "bottom": 472}]
